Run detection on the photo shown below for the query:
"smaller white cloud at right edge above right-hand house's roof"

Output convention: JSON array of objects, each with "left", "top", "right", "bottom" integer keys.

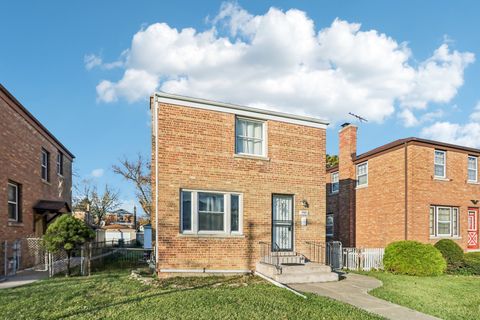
[{"left": 420, "top": 102, "right": 480, "bottom": 148}]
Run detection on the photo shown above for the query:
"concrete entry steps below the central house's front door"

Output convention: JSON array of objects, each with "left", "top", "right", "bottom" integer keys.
[{"left": 256, "top": 262, "right": 338, "bottom": 284}]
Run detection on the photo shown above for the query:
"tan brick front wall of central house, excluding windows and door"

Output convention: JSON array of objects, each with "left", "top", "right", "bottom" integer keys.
[{"left": 152, "top": 104, "right": 325, "bottom": 270}]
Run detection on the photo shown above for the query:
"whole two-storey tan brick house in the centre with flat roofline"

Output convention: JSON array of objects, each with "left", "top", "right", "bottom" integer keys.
[{"left": 151, "top": 93, "right": 327, "bottom": 276}]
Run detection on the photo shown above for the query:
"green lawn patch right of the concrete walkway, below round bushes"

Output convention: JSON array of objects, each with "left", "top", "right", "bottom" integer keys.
[{"left": 366, "top": 272, "right": 480, "bottom": 319}]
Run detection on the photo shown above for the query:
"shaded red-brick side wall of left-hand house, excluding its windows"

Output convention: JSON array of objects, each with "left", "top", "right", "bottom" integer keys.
[{"left": 0, "top": 91, "right": 72, "bottom": 241}]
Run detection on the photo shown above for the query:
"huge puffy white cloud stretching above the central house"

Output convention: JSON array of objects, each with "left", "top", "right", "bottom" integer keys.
[{"left": 93, "top": 3, "right": 474, "bottom": 125}]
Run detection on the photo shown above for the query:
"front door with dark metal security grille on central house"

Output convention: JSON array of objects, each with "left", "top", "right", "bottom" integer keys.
[{"left": 272, "top": 194, "right": 293, "bottom": 251}]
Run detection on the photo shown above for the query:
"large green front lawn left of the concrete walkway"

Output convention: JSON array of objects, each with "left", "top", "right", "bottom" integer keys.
[{"left": 0, "top": 271, "right": 380, "bottom": 320}]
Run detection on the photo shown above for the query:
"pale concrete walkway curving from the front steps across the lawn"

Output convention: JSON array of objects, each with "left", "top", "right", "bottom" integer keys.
[{"left": 289, "top": 273, "right": 439, "bottom": 320}]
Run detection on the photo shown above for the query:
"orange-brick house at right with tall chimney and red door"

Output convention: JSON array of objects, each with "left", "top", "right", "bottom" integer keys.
[{"left": 326, "top": 124, "right": 480, "bottom": 250}]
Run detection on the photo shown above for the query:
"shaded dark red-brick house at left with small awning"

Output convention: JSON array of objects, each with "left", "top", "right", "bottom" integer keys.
[{"left": 0, "top": 85, "right": 74, "bottom": 241}]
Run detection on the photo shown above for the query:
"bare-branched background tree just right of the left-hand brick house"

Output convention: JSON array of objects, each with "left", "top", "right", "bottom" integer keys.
[{"left": 73, "top": 180, "right": 121, "bottom": 225}]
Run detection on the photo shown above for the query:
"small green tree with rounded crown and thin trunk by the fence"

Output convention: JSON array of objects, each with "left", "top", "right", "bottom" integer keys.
[{"left": 43, "top": 214, "right": 95, "bottom": 276}]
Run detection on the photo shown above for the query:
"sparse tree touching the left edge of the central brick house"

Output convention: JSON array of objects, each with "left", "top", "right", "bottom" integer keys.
[{"left": 112, "top": 154, "right": 152, "bottom": 216}]
